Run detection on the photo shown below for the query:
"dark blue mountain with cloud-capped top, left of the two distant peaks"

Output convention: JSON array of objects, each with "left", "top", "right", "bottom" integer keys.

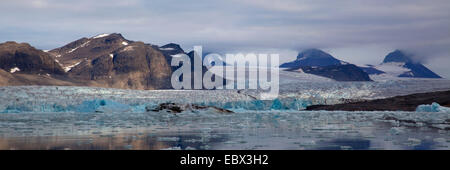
[{"left": 280, "top": 49, "right": 371, "bottom": 81}]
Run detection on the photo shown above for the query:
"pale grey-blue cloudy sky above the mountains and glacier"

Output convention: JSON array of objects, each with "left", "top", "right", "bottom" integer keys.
[{"left": 0, "top": 0, "right": 450, "bottom": 78}]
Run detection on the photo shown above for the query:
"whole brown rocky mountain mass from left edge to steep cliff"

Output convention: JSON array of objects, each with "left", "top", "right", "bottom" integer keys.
[{"left": 0, "top": 34, "right": 172, "bottom": 90}]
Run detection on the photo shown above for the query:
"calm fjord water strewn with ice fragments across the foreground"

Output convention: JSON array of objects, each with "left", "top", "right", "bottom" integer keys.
[{"left": 0, "top": 112, "right": 450, "bottom": 150}]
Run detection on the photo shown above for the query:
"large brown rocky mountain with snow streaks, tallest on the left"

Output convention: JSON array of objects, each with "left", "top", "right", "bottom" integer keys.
[{"left": 55, "top": 34, "right": 172, "bottom": 89}]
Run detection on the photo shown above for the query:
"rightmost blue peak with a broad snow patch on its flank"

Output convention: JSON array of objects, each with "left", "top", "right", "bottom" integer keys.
[{"left": 360, "top": 50, "right": 441, "bottom": 78}]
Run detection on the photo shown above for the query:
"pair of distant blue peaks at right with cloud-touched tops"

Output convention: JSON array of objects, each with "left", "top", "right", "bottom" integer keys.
[{"left": 280, "top": 49, "right": 441, "bottom": 81}]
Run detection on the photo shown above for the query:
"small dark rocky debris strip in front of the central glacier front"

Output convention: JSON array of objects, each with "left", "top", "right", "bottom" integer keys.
[{"left": 146, "top": 103, "right": 234, "bottom": 114}]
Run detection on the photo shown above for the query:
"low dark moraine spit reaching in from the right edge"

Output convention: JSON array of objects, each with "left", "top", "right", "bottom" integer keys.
[{"left": 306, "top": 91, "right": 450, "bottom": 111}]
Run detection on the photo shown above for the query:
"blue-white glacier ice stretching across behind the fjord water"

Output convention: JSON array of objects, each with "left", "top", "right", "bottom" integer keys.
[{"left": 0, "top": 76, "right": 450, "bottom": 113}]
